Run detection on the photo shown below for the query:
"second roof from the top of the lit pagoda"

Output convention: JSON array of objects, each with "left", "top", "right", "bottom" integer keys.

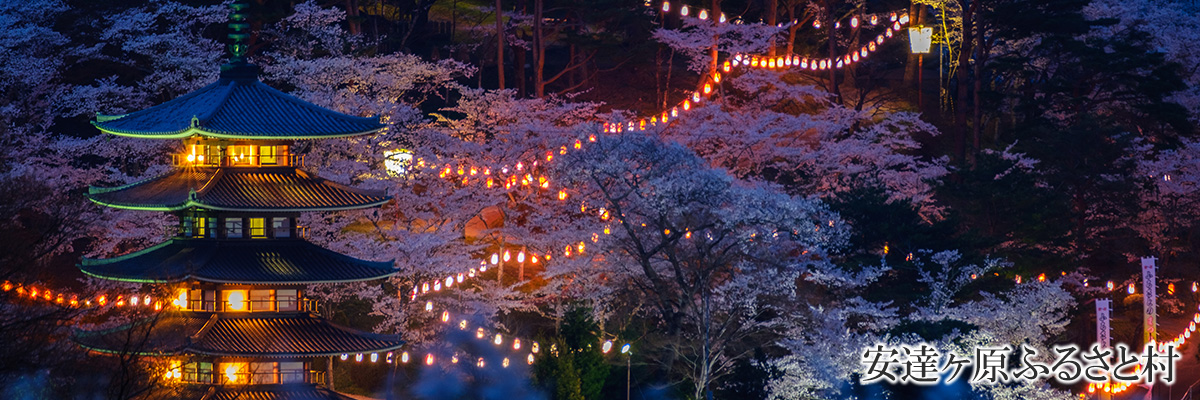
[{"left": 88, "top": 167, "right": 391, "bottom": 211}]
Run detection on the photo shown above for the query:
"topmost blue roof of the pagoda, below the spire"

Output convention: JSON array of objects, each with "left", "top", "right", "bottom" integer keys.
[{"left": 91, "top": 65, "right": 384, "bottom": 139}]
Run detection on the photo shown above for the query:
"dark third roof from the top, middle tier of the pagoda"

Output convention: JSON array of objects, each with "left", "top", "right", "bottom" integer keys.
[{"left": 79, "top": 238, "right": 396, "bottom": 285}]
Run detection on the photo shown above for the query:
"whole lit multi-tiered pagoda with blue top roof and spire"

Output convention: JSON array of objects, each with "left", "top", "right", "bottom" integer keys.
[{"left": 76, "top": 4, "right": 402, "bottom": 399}]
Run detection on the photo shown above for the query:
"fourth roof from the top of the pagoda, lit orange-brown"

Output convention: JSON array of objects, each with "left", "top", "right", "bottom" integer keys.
[{"left": 73, "top": 311, "right": 404, "bottom": 358}]
